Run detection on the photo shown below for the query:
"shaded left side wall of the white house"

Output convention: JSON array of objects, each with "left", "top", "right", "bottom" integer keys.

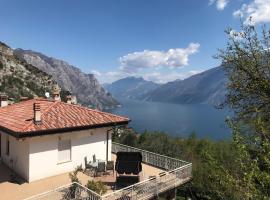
[{"left": 0, "top": 132, "right": 29, "bottom": 180}]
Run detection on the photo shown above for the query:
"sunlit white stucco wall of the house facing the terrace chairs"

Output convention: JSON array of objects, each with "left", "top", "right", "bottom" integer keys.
[{"left": 28, "top": 128, "right": 111, "bottom": 182}]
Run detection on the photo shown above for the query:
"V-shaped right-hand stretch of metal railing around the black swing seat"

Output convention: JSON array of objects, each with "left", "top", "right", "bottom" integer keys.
[{"left": 102, "top": 142, "right": 192, "bottom": 200}]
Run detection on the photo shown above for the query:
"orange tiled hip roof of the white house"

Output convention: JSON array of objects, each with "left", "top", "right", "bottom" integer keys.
[{"left": 0, "top": 99, "right": 129, "bottom": 137}]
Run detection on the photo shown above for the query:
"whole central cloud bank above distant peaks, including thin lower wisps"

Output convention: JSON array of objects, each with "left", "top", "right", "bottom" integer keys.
[{"left": 91, "top": 43, "right": 200, "bottom": 83}]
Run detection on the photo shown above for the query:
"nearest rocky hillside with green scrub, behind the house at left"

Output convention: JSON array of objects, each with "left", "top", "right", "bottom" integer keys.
[{"left": 0, "top": 42, "right": 56, "bottom": 101}]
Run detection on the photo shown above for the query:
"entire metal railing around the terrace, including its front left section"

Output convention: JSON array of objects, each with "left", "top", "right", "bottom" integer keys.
[{"left": 24, "top": 142, "right": 192, "bottom": 200}]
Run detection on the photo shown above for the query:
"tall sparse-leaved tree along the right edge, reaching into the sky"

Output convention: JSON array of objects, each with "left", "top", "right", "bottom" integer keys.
[{"left": 218, "top": 21, "right": 270, "bottom": 199}]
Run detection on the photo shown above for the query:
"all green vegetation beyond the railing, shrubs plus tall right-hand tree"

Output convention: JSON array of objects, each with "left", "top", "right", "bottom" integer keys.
[{"left": 113, "top": 22, "right": 270, "bottom": 200}]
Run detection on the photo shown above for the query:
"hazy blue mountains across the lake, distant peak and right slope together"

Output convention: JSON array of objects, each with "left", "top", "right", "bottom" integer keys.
[{"left": 105, "top": 66, "right": 228, "bottom": 106}]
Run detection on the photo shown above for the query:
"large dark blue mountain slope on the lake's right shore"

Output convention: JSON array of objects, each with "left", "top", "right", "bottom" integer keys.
[{"left": 144, "top": 67, "right": 228, "bottom": 105}]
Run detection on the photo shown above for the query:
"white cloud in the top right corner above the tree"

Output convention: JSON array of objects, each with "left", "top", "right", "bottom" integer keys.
[{"left": 233, "top": 0, "right": 270, "bottom": 25}]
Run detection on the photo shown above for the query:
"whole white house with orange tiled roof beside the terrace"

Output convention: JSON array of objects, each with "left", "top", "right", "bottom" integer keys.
[{"left": 0, "top": 98, "right": 129, "bottom": 182}]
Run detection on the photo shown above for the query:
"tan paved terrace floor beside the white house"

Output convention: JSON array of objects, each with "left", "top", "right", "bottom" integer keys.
[{"left": 0, "top": 154, "right": 163, "bottom": 200}]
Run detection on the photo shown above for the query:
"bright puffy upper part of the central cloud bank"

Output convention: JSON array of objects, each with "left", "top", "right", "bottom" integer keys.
[{"left": 119, "top": 43, "right": 200, "bottom": 73}]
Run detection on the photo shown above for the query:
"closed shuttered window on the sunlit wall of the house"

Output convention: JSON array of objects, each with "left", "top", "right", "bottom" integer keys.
[{"left": 58, "top": 140, "right": 71, "bottom": 163}]
